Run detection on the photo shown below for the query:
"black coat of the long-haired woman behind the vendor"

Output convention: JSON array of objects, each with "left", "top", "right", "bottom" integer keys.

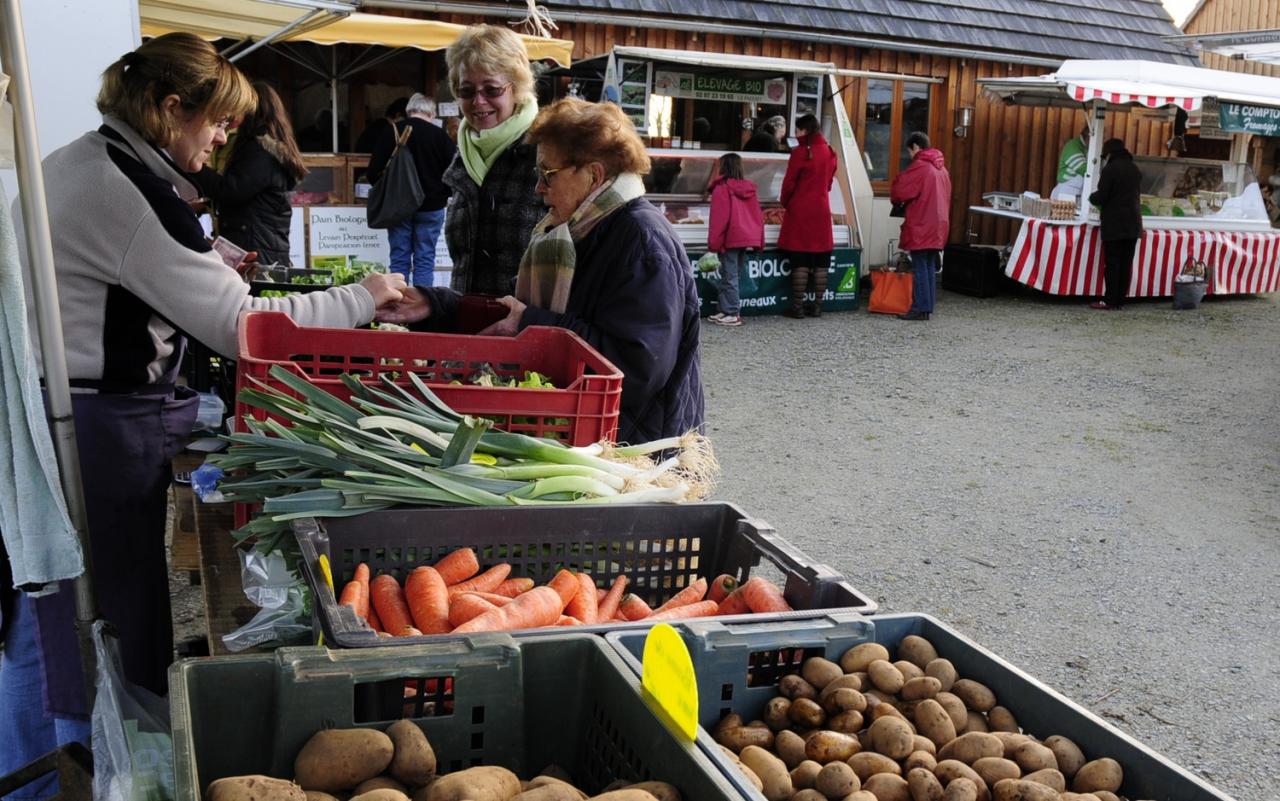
[{"left": 195, "top": 132, "right": 298, "bottom": 264}]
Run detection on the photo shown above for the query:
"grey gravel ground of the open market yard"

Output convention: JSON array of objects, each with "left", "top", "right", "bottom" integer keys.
[{"left": 703, "top": 286, "right": 1280, "bottom": 801}]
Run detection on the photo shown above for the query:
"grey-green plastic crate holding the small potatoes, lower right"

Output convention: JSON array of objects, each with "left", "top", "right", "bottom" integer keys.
[{"left": 605, "top": 614, "right": 1233, "bottom": 801}]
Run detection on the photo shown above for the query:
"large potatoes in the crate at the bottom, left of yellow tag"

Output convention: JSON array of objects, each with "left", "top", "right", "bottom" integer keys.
[{"left": 205, "top": 720, "right": 681, "bottom": 801}]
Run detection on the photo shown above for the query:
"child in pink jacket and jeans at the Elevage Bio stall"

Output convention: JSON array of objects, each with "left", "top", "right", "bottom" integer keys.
[{"left": 707, "top": 154, "right": 764, "bottom": 325}]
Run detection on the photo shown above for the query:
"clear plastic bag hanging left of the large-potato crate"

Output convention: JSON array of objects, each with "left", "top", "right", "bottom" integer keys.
[{"left": 93, "top": 621, "right": 175, "bottom": 801}]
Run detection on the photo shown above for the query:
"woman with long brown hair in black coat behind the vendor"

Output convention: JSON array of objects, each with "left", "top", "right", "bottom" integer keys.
[{"left": 195, "top": 82, "right": 307, "bottom": 265}]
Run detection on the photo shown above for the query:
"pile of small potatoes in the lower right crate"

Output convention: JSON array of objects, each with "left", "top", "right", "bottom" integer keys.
[{"left": 713, "top": 635, "right": 1146, "bottom": 801}]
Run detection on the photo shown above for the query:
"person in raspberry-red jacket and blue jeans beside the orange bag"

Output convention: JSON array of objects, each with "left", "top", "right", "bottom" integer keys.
[{"left": 888, "top": 131, "right": 951, "bottom": 320}]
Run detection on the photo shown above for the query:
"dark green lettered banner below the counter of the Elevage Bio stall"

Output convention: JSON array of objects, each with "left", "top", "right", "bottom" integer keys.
[{"left": 687, "top": 247, "right": 861, "bottom": 316}]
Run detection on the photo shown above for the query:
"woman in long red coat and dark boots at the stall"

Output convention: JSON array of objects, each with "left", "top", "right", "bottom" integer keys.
[{"left": 778, "top": 114, "right": 836, "bottom": 319}]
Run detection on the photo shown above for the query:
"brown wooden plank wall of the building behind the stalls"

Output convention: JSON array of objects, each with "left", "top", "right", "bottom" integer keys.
[{"left": 435, "top": 10, "right": 1172, "bottom": 243}]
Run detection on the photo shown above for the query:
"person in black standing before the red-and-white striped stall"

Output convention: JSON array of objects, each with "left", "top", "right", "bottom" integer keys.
[{"left": 1089, "top": 139, "right": 1142, "bottom": 311}]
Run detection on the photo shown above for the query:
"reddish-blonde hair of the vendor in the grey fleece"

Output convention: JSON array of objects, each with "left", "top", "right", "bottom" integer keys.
[{"left": 97, "top": 33, "right": 257, "bottom": 147}]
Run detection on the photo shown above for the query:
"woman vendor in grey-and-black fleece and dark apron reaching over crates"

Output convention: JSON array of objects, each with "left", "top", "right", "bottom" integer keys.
[{"left": 0, "top": 33, "right": 403, "bottom": 774}]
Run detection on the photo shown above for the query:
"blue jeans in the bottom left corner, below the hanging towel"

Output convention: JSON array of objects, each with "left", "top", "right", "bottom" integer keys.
[{"left": 0, "top": 592, "right": 90, "bottom": 801}]
